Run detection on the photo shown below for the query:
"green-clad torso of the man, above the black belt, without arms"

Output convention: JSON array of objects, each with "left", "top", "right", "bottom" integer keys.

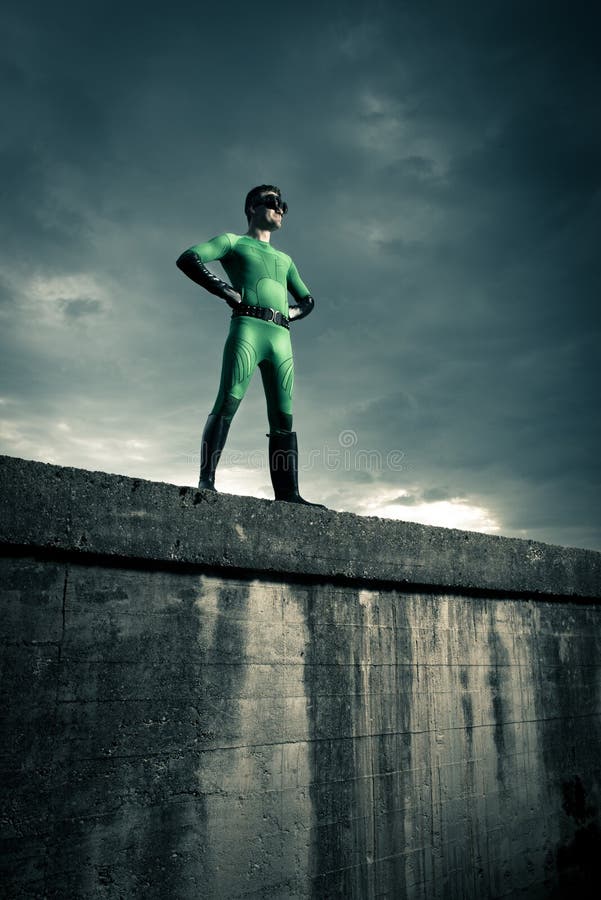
[{"left": 221, "top": 234, "right": 292, "bottom": 315}]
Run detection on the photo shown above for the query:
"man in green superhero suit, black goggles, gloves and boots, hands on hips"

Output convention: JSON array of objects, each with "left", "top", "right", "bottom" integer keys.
[{"left": 177, "top": 184, "right": 321, "bottom": 506}]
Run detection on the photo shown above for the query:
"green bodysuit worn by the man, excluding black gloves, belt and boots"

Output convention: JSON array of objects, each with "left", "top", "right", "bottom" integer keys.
[{"left": 190, "top": 233, "right": 310, "bottom": 434}]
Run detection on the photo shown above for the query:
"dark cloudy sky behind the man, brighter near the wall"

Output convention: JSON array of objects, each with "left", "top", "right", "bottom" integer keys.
[{"left": 0, "top": 0, "right": 601, "bottom": 549}]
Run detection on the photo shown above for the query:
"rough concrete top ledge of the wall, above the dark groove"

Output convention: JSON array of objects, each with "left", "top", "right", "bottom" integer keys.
[{"left": 0, "top": 456, "right": 601, "bottom": 597}]
